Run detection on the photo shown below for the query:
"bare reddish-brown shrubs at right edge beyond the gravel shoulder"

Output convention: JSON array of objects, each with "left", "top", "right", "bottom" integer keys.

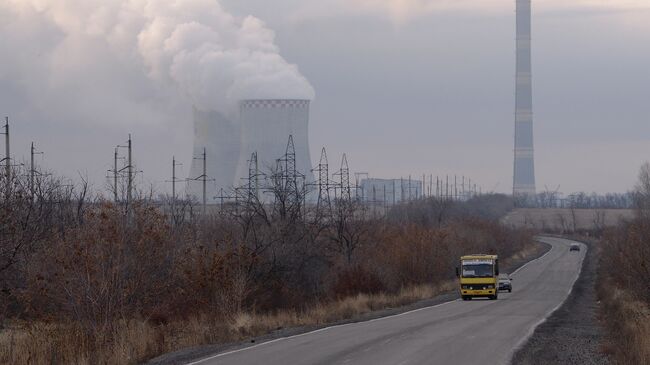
[{"left": 598, "top": 163, "right": 650, "bottom": 364}]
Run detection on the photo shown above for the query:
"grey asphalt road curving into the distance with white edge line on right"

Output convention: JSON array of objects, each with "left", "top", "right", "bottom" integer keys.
[{"left": 186, "top": 238, "right": 587, "bottom": 365}]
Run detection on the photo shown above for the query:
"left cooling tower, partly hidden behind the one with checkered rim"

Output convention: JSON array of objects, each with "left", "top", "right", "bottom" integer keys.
[{"left": 187, "top": 108, "right": 240, "bottom": 203}]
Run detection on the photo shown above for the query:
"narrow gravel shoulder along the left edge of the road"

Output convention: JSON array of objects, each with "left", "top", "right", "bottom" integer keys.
[{"left": 147, "top": 242, "right": 551, "bottom": 365}]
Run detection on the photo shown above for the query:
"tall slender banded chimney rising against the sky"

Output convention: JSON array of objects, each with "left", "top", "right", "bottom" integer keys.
[{"left": 513, "top": 0, "right": 535, "bottom": 195}]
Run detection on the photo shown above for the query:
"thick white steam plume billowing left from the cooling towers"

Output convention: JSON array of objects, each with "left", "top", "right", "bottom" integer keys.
[{"left": 0, "top": 0, "right": 314, "bottom": 113}]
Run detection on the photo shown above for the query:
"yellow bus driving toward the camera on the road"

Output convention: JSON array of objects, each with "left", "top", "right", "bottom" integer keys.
[{"left": 456, "top": 254, "right": 499, "bottom": 300}]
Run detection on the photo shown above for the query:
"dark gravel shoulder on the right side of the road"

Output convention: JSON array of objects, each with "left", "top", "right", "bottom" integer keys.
[{"left": 512, "top": 239, "right": 609, "bottom": 365}]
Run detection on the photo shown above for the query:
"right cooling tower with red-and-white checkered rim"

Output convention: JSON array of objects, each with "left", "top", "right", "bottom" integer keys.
[{"left": 236, "top": 100, "right": 313, "bottom": 185}]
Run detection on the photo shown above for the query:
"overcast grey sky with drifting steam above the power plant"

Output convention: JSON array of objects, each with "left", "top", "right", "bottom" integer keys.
[{"left": 0, "top": 0, "right": 650, "bottom": 193}]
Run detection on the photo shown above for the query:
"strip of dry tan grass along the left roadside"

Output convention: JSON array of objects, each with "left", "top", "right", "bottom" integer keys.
[{"left": 0, "top": 282, "right": 455, "bottom": 364}]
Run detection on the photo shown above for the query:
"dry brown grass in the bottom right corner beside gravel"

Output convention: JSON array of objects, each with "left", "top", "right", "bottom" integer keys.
[{"left": 601, "top": 286, "right": 650, "bottom": 365}]
